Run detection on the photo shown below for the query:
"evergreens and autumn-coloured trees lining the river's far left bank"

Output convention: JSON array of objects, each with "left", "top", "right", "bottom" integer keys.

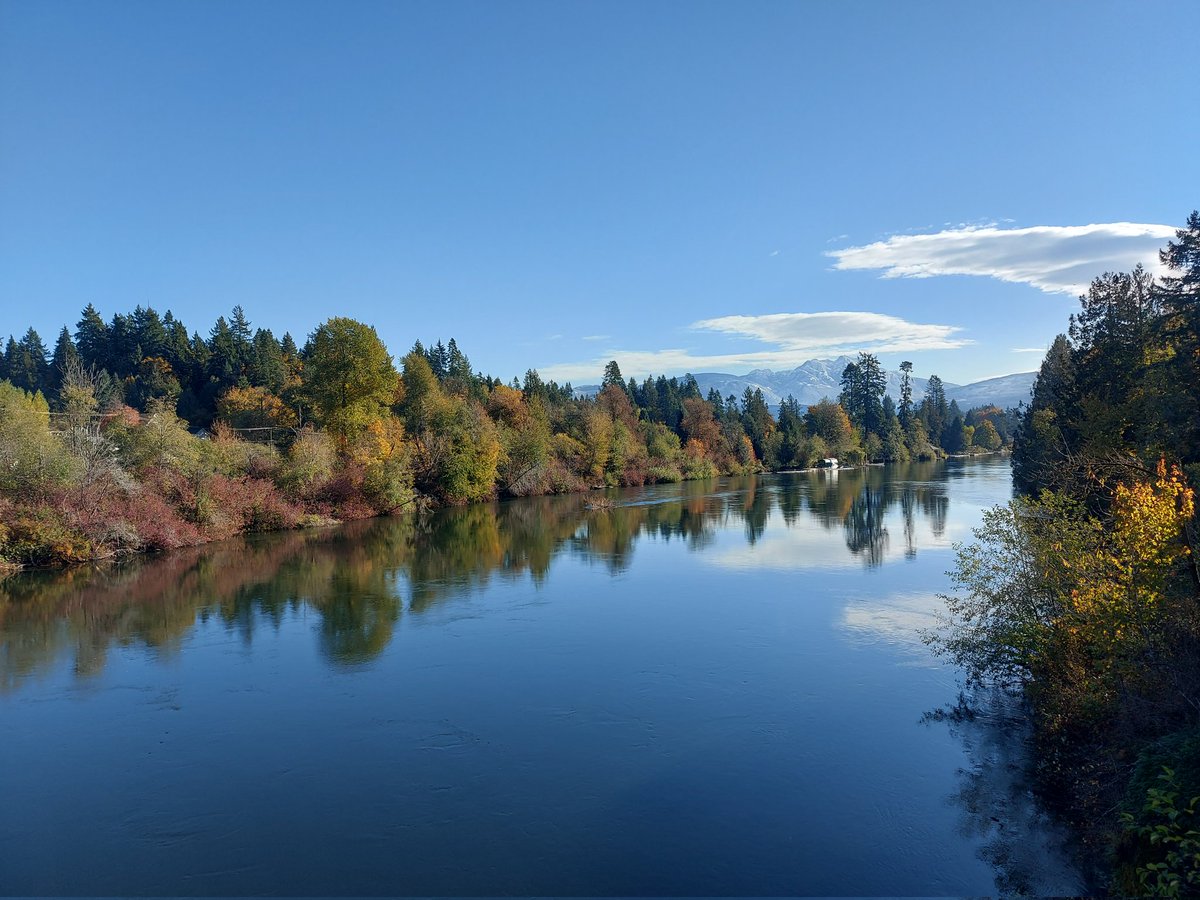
[{"left": 0, "top": 296, "right": 1016, "bottom": 568}]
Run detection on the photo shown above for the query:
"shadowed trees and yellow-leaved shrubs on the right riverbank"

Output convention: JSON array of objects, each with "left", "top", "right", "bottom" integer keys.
[{"left": 930, "top": 212, "right": 1200, "bottom": 896}]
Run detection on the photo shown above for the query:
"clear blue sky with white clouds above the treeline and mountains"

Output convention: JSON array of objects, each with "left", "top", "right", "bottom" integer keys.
[{"left": 0, "top": 0, "right": 1200, "bottom": 384}]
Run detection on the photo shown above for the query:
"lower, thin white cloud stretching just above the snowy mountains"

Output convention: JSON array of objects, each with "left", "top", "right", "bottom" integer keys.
[{"left": 539, "top": 312, "right": 972, "bottom": 383}]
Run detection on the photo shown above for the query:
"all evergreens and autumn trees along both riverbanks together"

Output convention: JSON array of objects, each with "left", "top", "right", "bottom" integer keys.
[{"left": 0, "top": 212, "right": 1200, "bottom": 895}]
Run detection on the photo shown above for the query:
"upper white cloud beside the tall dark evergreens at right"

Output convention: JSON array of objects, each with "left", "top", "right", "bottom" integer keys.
[{"left": 826, "top": 222, "right": 1175, "bottom": 295}]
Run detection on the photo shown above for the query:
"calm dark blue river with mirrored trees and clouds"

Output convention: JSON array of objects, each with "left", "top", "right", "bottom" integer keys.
[{"left": 0, "top": 460, "right": 1081, "bottom": 895}]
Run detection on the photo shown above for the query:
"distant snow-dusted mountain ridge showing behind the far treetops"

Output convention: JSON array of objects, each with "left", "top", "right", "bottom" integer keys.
[{"left": 577, "top": 356, "right": 1038, "bottom": 412}]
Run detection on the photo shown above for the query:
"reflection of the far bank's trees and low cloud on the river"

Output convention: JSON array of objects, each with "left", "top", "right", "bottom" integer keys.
[{"left": 0, "top": 463, "right": 964, "bottom": 691}]
